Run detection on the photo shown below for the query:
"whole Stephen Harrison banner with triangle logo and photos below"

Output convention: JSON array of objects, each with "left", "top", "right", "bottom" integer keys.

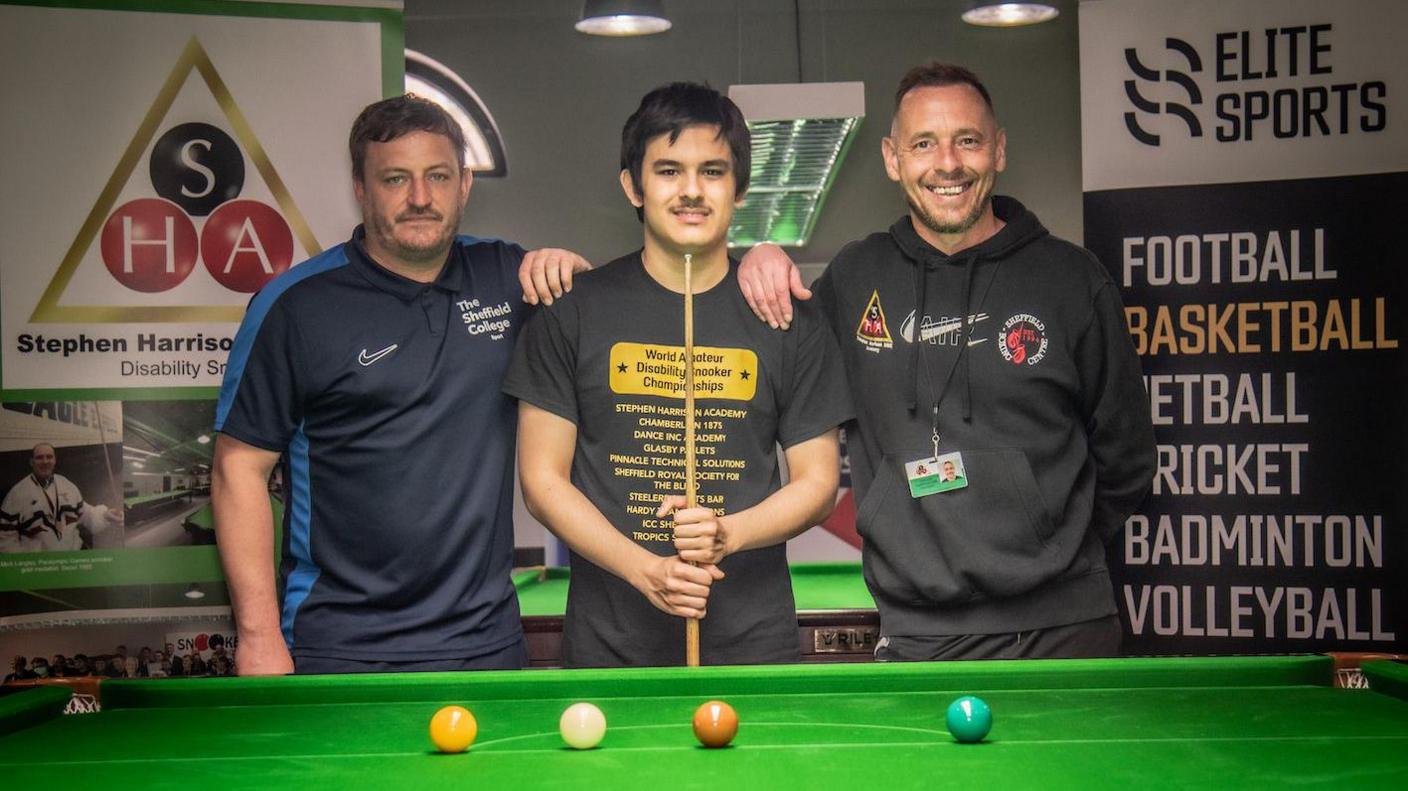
[{"left": 0, "top": 0, "right": 404, "bottom": 631}]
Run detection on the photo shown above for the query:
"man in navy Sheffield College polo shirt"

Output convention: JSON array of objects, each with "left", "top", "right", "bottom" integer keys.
[{"left": 211, "top": 96, "right": 587, "bottom": 676}]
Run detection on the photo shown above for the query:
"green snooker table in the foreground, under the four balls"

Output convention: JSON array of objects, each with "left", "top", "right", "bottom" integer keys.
[{"left": 0, "top": 656, "right": 1408, "bottom": 791}]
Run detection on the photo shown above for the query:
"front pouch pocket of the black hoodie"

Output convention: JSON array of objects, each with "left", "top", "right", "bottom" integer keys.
[{"left": 856, "top": 448, "right": 1069, "bottom": 604}]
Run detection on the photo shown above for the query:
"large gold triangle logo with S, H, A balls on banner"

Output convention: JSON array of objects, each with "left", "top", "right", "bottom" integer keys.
[{"left": 30, "top": 37, "right": 321, "bottom": 322}]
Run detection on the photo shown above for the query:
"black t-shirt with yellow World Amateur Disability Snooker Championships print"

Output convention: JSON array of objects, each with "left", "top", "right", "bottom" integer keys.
[{"left": 504, "top": 253, "right": 852, "bottom": 667}]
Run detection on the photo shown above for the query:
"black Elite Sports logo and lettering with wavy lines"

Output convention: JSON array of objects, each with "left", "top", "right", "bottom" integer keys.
[{"left": 1124, "top": 23, "right": 1388, "bottom": 146}]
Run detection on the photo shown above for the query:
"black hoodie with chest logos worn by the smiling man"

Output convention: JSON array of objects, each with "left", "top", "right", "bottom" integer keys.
[{"left": 817, "top": 197, "right": 1155, "bottom": 635}]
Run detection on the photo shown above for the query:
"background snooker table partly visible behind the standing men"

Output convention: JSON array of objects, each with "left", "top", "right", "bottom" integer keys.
[{"left": 514, "top": 563, "right": 880, "bottom": 667}]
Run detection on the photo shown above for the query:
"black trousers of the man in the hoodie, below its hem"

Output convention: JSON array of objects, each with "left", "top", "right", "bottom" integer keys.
[{"left": 876, "top": 615, "right": 1124, "bottom": 662}]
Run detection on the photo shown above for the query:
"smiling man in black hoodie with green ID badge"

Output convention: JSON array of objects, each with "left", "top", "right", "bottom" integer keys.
[{"left": 739, "top": 63, "right": 1155, "bottom": 660}]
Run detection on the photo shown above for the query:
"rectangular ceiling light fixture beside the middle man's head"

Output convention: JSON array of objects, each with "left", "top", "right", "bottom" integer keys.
[{"left": 728, "top": 82, "right": 866, "bottom": 248}]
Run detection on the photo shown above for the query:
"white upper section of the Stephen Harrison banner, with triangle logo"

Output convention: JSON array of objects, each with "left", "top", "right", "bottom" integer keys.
[{"left": 0, "top": 1, "right": 404, "bottom": 394}]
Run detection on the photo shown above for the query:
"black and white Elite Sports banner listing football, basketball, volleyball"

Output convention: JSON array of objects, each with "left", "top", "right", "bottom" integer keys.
[{"left": 1080, "top": 0, "right": 1408, "bottom": 653}]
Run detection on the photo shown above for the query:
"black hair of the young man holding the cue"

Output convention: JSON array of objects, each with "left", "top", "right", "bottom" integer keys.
[{"left": 621, "top": 83, "right": 753, "bottom": 217}]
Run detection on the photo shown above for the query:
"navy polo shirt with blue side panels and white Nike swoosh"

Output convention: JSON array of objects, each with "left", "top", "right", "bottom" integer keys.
[{"left": 215, "top": 228, "right": 527, "bottom": 662}]
